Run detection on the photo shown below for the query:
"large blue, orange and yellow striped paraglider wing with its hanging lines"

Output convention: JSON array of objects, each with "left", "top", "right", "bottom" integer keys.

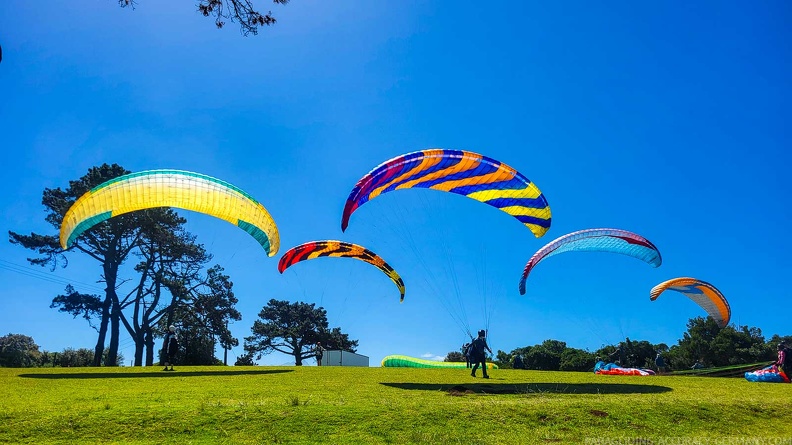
[{"left": 341, "top": 148, "right": 552, "bottom": 338}]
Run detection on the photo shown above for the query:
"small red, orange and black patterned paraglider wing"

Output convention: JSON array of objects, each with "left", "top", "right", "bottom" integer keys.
[{"left": 278, "top": 240, "right": 404, "bottom": 302}]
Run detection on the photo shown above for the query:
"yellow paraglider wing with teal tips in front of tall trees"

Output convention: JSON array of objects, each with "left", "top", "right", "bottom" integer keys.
[{"left": 60, "top": 169, "right": 280, "bottom": 256}]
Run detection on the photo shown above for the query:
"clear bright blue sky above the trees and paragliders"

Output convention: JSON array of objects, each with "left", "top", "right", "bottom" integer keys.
[{"left": 0, "top": 0, "right": 792, "bottom": 366}]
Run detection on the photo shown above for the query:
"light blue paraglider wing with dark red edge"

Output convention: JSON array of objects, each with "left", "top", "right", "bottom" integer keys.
[{"left": 520, "top": 229, "right": 663, "bottom": 295}]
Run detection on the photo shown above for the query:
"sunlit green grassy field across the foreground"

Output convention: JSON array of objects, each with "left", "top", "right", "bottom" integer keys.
[{"left": 0, "top": 366, "right": 792, "bottom": 444}]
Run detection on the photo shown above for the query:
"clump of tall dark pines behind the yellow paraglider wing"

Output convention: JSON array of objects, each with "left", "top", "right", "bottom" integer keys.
[{"left": 9, "top": 164, "right": 241, "bottom": 366}]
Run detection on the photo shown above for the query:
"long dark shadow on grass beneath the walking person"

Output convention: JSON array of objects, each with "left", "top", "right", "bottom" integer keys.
[{"left": 380, "top": 382, "right": 671, "bottom": 396}]
